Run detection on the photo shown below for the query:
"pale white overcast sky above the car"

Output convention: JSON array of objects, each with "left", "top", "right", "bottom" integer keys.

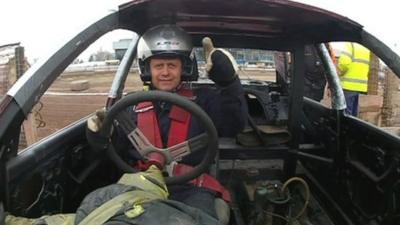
[{"left": 0, "top": 0, "right": 400, "bottom": 62}]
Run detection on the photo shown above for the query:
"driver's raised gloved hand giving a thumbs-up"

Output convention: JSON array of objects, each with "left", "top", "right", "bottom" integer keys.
[{"left": 203, "top": 37, "right": 238, "bottom": 86}]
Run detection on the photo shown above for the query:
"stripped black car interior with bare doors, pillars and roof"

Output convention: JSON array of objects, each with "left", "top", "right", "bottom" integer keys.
[{"left": 0, "top": 0, "right": 400, "bottom": 225}]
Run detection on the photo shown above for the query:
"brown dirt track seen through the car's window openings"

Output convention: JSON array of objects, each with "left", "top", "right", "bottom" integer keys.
[{"left": 34, "top": 70, "right": 275, "bottom": 140}]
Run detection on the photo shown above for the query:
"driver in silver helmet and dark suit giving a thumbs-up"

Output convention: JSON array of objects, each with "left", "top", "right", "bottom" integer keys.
[{"left": 88, "top": 25, "right": 247, "bottom": 221}]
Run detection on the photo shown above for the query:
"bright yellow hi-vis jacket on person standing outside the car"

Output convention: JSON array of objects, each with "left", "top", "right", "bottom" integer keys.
[{"left": 338, "top": 43, "right": 370, "bottom": 93}]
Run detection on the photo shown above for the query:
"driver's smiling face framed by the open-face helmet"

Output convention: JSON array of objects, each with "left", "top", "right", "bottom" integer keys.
[{"left": 150, "top": 58, "right": 182, "bottom": 91}]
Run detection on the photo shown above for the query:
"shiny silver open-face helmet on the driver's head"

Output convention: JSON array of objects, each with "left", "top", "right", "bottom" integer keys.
[{"left": 137, "top": 24, "right": 199, "bottom": 82}]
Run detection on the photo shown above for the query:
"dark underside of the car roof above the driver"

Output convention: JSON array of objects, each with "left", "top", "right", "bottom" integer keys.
[{"left": 119, "top": 0, "right": 362, "bottom": 50}]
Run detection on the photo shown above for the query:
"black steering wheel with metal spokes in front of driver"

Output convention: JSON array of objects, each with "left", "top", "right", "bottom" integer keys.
[{"left": 100, "top": 91, "right": 218, "bottom": 184}]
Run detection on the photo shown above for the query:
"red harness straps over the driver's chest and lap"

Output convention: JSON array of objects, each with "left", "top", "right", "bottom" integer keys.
[{"left": 135, "top": 88, "right": 231, "bottom": 202}]
